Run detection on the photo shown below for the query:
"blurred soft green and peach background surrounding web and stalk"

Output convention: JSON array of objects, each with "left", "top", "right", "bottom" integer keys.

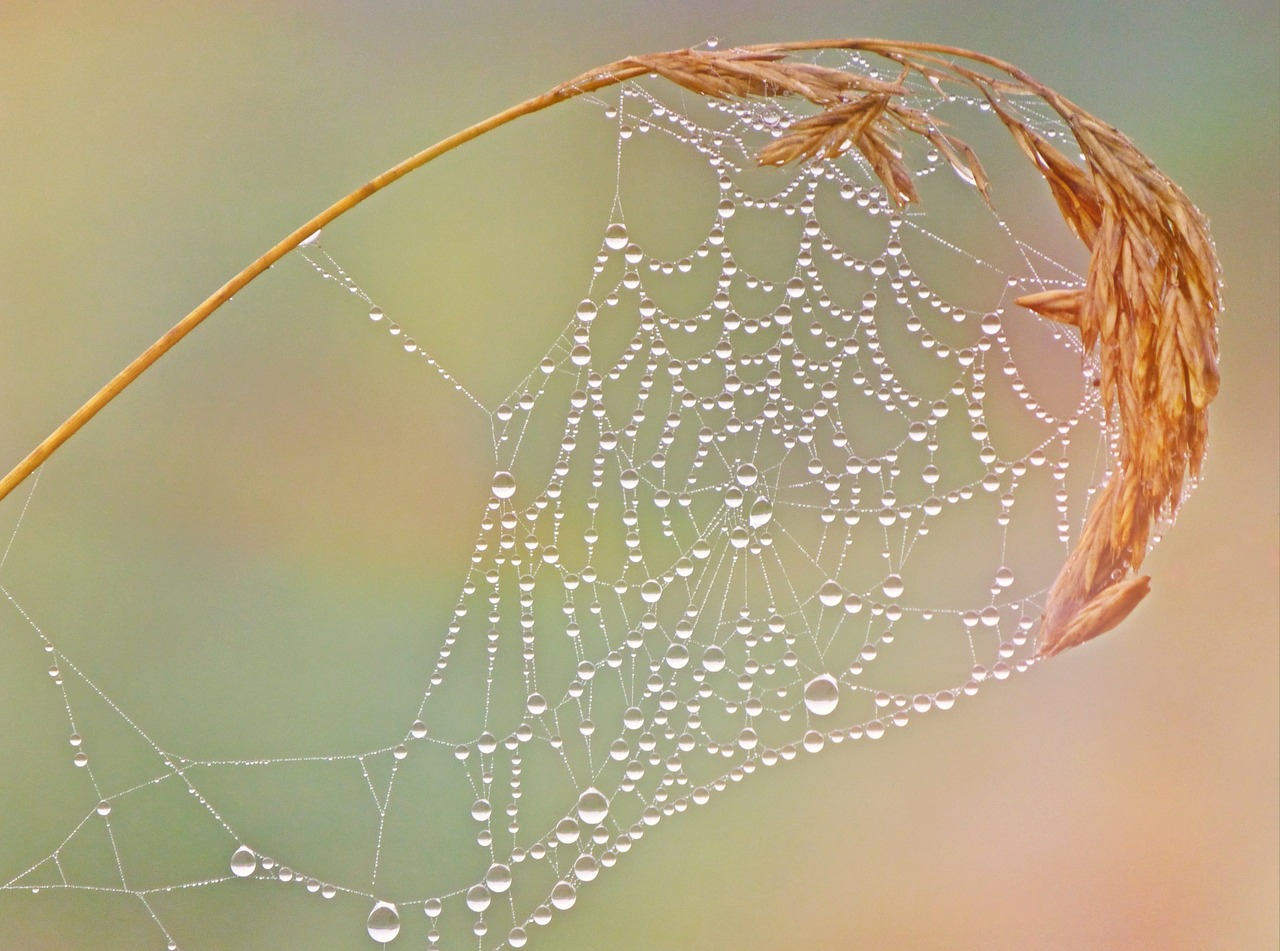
[{"left": 0, "top": 0, "right": 1280, "bottom": 951}]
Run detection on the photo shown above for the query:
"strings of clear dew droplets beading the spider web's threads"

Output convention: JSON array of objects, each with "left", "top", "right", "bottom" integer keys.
[{"left": 5, "top": 59, "right": 1114, "bottom": 947}]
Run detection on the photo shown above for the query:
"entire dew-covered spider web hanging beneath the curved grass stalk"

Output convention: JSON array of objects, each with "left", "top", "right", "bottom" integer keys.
[{"left": 0, "top": 56, "right": 1131, "bottom": 948}]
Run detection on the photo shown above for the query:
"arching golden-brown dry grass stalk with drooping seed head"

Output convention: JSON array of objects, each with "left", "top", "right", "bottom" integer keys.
[{"left": 0, "top": 40, "right": 1221, "bottom": 655}]
